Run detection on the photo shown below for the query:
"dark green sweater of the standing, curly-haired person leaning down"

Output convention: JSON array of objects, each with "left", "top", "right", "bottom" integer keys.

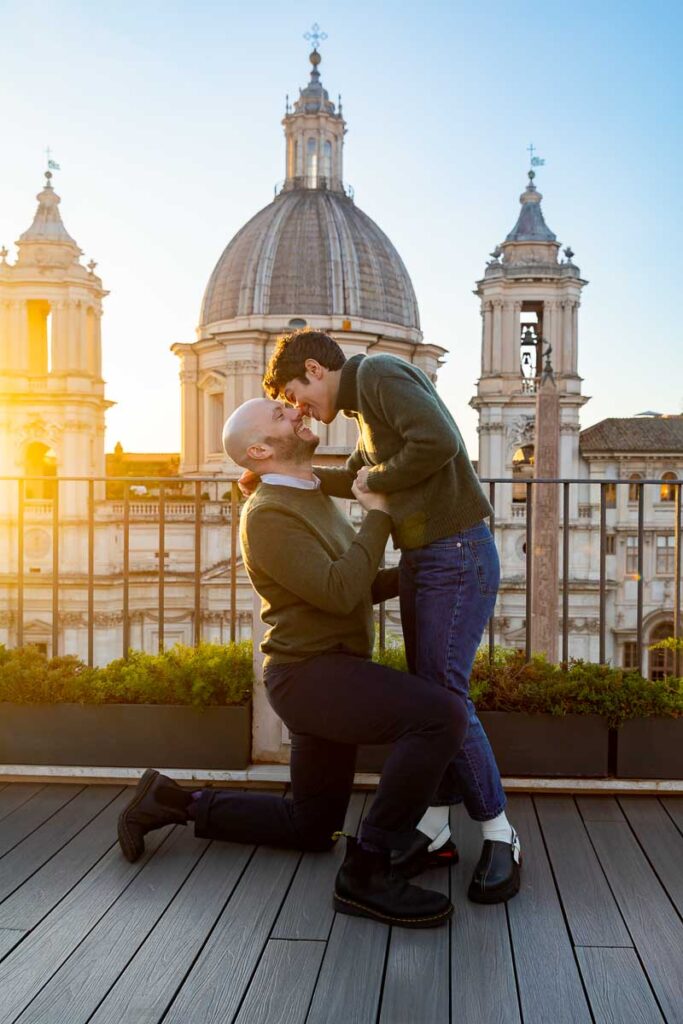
[{"left": 315, "top": 355, "right": 493, "bottom": 548}]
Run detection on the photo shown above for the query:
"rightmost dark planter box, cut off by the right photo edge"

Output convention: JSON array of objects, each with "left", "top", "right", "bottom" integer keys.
[{"left": 616, "top": 718, "right": 683, "bottom": 778}]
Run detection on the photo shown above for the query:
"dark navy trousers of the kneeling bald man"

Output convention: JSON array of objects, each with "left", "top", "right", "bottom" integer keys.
[{"left": 195, "top": 653, "right": 467, "bottom": 850}]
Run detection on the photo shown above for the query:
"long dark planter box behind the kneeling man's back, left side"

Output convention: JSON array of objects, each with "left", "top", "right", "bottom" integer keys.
[{"left": 0, "top": 703, "right": 251, "bottom": 769}]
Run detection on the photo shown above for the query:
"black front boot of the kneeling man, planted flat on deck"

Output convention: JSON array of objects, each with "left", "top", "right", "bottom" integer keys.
[{"left": 334, "top": 837, "right": 453, "bottom": 928}]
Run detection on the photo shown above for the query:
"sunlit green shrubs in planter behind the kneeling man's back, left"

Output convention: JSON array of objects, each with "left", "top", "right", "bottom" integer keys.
[{"left": 0, "top": 641, "right": 253, "bottom": 708}]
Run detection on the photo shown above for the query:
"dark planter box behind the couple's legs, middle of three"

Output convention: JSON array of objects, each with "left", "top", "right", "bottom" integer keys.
[{"left": 356, "top": 711, "right": 609, "bottom": 778}]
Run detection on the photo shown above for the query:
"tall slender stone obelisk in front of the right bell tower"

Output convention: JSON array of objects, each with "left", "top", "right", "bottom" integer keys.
[{"left": 531, "top": 346, "right": 560, "bottom": 663}]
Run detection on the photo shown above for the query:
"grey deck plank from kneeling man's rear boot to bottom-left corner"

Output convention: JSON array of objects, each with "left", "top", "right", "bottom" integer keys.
[{"left": 0, "top": 828, "right": 174, "bottom": 1024}]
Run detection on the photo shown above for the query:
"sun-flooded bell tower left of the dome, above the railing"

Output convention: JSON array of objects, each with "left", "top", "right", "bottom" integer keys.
[{"left": 0, "top": 171, "right": 112, "bottom": 516}]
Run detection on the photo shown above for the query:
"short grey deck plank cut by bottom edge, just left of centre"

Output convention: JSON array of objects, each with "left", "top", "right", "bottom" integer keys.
[{"left": 234, "top": 939, "right": 325, "bottom": 1024}]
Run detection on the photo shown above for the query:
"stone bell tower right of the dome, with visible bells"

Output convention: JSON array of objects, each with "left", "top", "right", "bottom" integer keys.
[{"left": 470, "top": 170, "right": 588, "bottom": 518}]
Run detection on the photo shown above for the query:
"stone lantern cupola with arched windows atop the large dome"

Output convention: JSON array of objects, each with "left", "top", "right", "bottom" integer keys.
[{"left": 283, "top": 49, "right": 346, "bottom": 191}]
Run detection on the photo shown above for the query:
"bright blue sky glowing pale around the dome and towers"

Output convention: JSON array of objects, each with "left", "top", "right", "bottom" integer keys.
[{"left": 0, "top": 0, "right": 683, "bottom": 456}]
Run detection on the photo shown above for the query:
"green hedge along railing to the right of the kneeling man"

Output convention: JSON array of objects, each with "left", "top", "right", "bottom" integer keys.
[{"left": 375, "top": 641, "right": 683, "bottom": 726}]
